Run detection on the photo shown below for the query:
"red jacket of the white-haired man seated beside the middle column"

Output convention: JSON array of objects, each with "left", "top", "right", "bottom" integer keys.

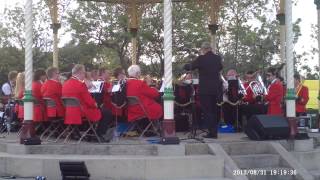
[{"left": 127, "top": 79, "right": 163, "bottom": 122}]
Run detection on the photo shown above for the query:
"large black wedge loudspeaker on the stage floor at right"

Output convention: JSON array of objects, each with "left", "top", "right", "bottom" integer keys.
[{"left": 245, "top": 115, "right": 290, "bottom": 140}]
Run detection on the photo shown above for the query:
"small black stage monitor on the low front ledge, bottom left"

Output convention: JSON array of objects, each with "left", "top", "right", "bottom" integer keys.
[{"left": 59, "top": 161, "right": 90, "bottom": 180}]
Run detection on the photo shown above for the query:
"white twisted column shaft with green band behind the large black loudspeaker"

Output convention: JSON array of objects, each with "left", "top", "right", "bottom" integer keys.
[{"left": 285, "top": 0, "right": 296, "bottom": 118}]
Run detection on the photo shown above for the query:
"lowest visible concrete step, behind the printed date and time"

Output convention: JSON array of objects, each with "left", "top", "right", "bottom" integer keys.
[{"left": 242, "top": 167, "right": 297, "bottom": 180}]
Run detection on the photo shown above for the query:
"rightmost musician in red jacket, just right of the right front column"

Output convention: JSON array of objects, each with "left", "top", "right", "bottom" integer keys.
[{"left": 294, "top": 74, "right": 309, "bottom": 116}]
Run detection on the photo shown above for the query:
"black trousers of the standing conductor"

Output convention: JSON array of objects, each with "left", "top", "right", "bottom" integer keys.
[{"left": 199, "top": 95, "right": 220, "bottom": 136}]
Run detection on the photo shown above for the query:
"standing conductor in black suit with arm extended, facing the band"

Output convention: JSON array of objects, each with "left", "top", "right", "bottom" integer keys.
[{"left": 184, "top": 42, "right": 222, "bottom": 139}]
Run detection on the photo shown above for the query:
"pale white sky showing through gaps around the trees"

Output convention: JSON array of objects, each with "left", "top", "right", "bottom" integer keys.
[{"left": 0, "top": 0, "right": 318, "bottom": 70}]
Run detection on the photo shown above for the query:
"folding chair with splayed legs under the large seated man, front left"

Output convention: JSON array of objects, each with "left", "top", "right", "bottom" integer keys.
[{"left": 56, "top": 97, "right": 101, "bottom": 144}]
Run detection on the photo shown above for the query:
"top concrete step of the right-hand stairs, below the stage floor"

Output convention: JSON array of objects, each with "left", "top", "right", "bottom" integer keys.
[{"left": 221, "top": 141, "right": 276, "bottom": 156}]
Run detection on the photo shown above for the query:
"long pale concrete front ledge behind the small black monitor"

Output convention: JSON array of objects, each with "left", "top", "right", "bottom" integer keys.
[{"left": 0, "top": 153, "right": 224, "bottom": 180}]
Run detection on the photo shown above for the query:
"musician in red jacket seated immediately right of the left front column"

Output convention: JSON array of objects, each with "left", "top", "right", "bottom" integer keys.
[{"left": 32, "top": 69, "right": 47, "bottom": 122}]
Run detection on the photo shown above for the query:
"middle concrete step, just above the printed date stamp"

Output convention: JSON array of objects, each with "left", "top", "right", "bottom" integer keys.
[{"left": 231, "top": 154, "right": 280, "bottom": 169}]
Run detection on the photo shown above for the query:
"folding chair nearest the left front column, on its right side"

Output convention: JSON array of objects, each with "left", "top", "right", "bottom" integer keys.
[{"left": 40, "top": 97, "right": 63, "bottom": 141}]
